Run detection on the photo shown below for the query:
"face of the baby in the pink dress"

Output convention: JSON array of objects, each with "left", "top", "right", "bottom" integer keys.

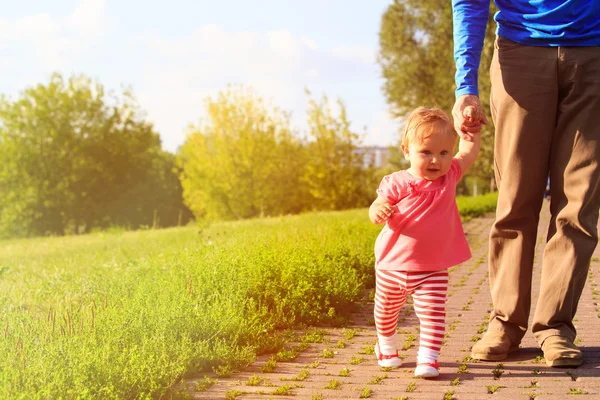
[{"left": 402, "top": 124, "right": 456, "bottom": 181}]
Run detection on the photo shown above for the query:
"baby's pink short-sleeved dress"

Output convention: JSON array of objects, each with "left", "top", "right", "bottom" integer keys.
[{"left": 375, "top": 159, "right": 471, "bottom": 271}]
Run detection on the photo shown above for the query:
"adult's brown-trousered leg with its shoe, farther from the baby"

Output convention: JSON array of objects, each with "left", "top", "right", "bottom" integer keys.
[{"left": 532, "top": 47, "right": 600, "bottom": 366}]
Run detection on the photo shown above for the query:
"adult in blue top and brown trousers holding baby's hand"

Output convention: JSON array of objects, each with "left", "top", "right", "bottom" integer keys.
[{"left": 452, "top": 0, "right": 600, "bottom": 367}]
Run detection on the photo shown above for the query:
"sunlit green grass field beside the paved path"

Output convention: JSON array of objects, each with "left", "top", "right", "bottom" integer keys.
[{"left": 0, "top": 191, "right": 495, "bottom": 399}]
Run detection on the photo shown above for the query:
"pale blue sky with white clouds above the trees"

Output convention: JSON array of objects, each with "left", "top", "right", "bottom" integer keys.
[{"left": 0, "top": 0, "right": 398, "bottom": 151}]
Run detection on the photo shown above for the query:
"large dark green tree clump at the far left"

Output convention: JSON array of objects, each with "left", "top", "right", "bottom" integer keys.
[{"left": 0, "top": 74, "right": 189, "bottom": 236}]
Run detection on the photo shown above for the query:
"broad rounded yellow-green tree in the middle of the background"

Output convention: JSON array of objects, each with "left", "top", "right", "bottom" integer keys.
[{"left": 178, "top": 86, "right": 307, "bottom": 219}]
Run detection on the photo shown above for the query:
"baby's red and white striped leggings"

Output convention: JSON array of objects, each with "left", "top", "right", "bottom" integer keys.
[{"left": 375, "top": 270, "right": 448, "bottom": 351}]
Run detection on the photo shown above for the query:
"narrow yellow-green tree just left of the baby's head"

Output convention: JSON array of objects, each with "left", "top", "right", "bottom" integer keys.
[{"left": 304, "top": 96, "right": 373, "bottom": 210}]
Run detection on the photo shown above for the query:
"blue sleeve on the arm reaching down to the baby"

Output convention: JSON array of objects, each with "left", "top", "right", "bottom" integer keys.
[{"left": 452, "top": 0, "right": 490, "bottom": 97}]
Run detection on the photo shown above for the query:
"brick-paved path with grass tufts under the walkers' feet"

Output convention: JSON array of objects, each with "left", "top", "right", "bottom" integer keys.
[{"left": 187, "top": 204, "right": 600, "bottom": 400}]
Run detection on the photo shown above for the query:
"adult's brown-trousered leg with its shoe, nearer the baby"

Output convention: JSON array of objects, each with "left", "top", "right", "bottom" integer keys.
[{"left": 472, "top": 37, "right": 558, "bottom": 360}]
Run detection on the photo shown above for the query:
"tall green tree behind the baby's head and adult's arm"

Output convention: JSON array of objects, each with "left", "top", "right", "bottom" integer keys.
[{"left": 378, "top": 0, "right": 495, "bottom": 191}]
